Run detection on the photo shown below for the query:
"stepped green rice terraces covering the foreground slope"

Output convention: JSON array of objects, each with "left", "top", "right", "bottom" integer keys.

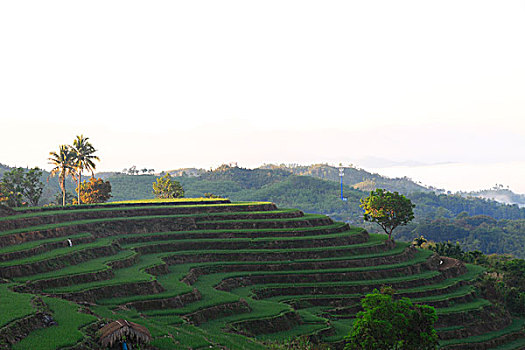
[{"left": 0, "top": 199, "right": 525, "bottom": 349}]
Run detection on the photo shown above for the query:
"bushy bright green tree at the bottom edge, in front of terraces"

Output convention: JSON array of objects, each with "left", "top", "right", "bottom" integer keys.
[{"left": 345, "top": 289, "right": 438, "bottom": 350}]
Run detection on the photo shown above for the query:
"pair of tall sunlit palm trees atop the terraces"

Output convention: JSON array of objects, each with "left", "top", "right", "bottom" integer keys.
[{"left": 48, "top": 135, "right": 100, "bottom": 205}]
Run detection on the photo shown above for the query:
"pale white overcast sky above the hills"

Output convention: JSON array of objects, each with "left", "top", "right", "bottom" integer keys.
[{"left": 0, "top": 0, "right": 525, "bottom": 193}]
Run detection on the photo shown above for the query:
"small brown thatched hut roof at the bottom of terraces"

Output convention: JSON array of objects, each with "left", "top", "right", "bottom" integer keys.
[{"left": 99, "top": 319, "right": 151, "bottom": 347}]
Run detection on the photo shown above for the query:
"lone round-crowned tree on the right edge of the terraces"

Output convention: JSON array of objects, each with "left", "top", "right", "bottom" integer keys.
[{"left": 361, "top": 188, "right": 415, "bottom": 240}]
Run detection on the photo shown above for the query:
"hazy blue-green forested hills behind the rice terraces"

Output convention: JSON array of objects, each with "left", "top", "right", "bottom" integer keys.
[{"left": 4, "top": 165, "right": 525, "bottom": 257}]
